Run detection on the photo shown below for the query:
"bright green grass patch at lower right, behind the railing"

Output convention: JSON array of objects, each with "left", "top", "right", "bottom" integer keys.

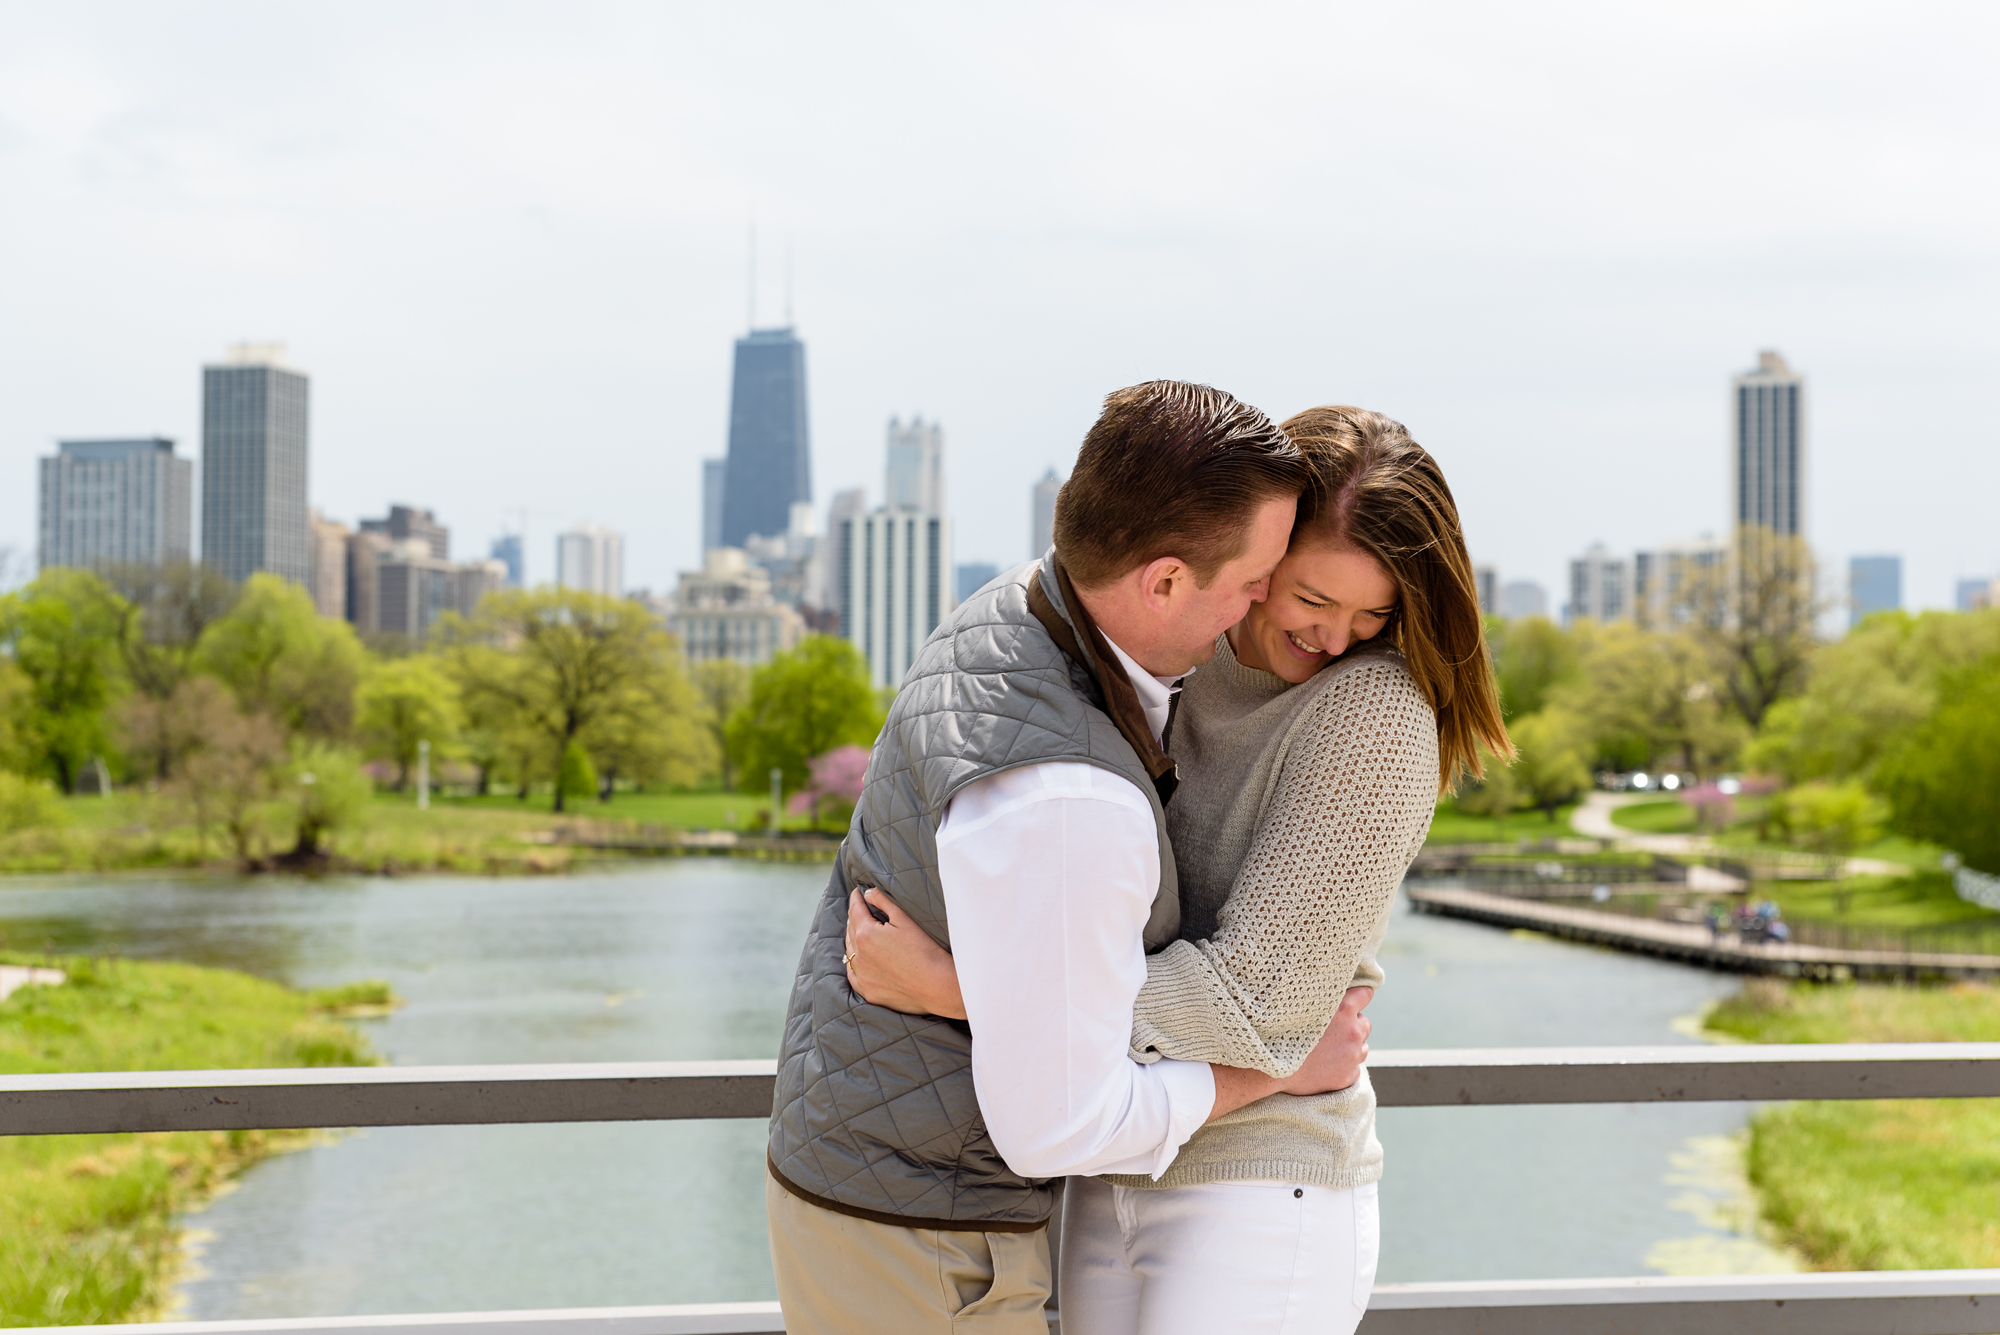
[{"left": 1708, "top": 979, "right": 2000, "bottom": 1269}]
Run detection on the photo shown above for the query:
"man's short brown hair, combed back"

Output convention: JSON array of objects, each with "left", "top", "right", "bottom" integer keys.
[{"left": 1056, "top": 380, "right": 1312, "bottom": 588}]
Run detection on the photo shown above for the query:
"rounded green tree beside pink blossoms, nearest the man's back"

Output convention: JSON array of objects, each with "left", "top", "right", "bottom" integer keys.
[{"left": 728, "top": 636, "right": 882, "bottom": 793}]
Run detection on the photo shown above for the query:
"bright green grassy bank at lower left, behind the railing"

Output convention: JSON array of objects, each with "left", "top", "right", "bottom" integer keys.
[{"left": 0, "top": 957, "right": 388, "bottom": 1327}]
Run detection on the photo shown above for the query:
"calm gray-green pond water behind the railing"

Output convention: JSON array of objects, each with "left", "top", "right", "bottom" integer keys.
[{"left": 0, "top": 859, "right": 1782, "bottom": 1319}]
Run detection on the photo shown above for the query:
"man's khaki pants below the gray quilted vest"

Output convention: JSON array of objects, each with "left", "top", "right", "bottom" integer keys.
[{"left": 764, "top": 1173, "right": 1048, "bottom": 1335}]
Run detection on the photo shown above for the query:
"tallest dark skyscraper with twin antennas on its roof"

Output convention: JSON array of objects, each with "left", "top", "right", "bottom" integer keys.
[{"left": 716, "top": 328, "right": 812, "bottom": 548}]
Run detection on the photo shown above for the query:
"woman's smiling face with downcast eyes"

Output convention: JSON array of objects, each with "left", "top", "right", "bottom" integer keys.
[{"left": 1230, "top": 544, "right": 1396, "bottom": 683}]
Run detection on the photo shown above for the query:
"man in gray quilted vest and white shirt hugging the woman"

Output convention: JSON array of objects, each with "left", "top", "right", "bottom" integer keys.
[{"left": 766, "top": 382, "right": 1348, "bottom": 1335}]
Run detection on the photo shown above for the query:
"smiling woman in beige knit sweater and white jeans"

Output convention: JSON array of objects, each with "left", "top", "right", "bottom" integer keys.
[{"left": 848, "top": 408, "right": 1512, "bottom": 1335}]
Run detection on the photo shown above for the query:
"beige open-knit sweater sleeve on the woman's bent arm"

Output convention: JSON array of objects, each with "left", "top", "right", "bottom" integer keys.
[{"left": 1132, "top": 658, "right": 1438, "bottom": 1077}]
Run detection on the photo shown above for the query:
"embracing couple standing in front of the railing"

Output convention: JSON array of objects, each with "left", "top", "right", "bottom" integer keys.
[{"left": 766, "top": 382, "right": 1510, "bottom": 1335}]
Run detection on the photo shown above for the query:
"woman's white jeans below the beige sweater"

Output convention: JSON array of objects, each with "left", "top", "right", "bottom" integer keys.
[{"left": 1056, "top": 1177, "right": 1382, "bottom": 1335}]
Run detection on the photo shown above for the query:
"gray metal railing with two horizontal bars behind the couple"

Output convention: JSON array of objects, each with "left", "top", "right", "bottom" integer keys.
[{"left": 11, "top": 1043, "right": 2000, "bottom": 1335}]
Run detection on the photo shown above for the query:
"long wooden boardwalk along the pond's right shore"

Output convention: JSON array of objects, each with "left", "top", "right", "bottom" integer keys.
[{"left": 1404, "top": 883, "right": 2000, "bottom": 979}]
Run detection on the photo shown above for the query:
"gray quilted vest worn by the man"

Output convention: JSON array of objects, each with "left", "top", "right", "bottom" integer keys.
[{"left": 770, "top": 564, "right": 1180, "bottom": 1231}]
